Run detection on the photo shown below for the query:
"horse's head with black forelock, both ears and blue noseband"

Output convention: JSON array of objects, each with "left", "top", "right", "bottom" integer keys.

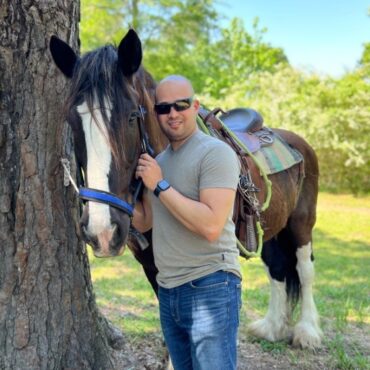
[{"left": 50, "top": 30, "right": 159, "bottom": 257}]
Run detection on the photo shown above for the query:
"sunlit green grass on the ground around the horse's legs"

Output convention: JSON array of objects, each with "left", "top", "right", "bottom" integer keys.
[{"left": 90, "top": 193, "right": 370, "bottom": 369}]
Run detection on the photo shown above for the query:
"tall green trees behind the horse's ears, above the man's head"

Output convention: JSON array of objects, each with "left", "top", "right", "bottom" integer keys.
[{"left": 81, "top": 0, "right": 219, "bottom": 91}]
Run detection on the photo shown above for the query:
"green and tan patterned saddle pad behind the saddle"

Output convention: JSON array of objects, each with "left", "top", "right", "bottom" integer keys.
[{"left": 253, "top": 133, "right": 303, "bottom": 175}]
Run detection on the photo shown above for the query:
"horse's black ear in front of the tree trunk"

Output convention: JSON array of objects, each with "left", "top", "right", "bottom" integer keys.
[{"left": 49, "top": 35, "right": 78, "bottom": 78}]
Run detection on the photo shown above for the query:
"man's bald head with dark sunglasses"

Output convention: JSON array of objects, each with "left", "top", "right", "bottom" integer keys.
[{"left": 155, "top": 75, "right": 199, "bottom": 149}]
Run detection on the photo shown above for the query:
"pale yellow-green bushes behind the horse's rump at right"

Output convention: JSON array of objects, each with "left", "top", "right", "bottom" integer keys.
[{"left": 202, "top": 65, "right": 370, "bottom": 194}]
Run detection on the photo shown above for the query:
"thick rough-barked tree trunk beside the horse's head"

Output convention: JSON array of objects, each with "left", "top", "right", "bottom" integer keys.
[{"left": 0, "top": 0, "right": 123, "bottom": 370}]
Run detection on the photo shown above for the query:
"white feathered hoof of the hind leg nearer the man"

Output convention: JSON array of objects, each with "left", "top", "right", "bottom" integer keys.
[{"left": 247, "top": 318, "right": 293, "bottom": 342}]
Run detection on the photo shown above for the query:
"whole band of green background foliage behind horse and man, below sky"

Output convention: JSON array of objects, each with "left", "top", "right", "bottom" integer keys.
[{"left": 81, "top": 0, "right": 370, "bottom": 194}]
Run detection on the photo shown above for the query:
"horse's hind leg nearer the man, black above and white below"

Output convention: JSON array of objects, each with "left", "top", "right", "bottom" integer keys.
[{"left": 248, "top": 238, "right": 292, "bottom": 342}]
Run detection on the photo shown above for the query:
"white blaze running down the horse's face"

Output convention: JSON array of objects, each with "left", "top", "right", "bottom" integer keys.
[{"left": 77, "top": 103, "right": 112, "bottom": 236}]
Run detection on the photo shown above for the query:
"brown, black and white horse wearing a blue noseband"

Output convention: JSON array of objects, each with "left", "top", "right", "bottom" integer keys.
[{"left": 50, "top": 29, "right": 322, "bottom": 348}]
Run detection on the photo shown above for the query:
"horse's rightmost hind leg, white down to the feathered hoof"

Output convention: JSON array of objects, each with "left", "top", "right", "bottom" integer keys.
[{"left": 293, "top": 242, "right": 322, "bottom": 349}]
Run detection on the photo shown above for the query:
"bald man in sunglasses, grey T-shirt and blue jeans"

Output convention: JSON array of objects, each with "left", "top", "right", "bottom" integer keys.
[{"left": 133, "top": 76, "right": 241, "bottom": 370}]
